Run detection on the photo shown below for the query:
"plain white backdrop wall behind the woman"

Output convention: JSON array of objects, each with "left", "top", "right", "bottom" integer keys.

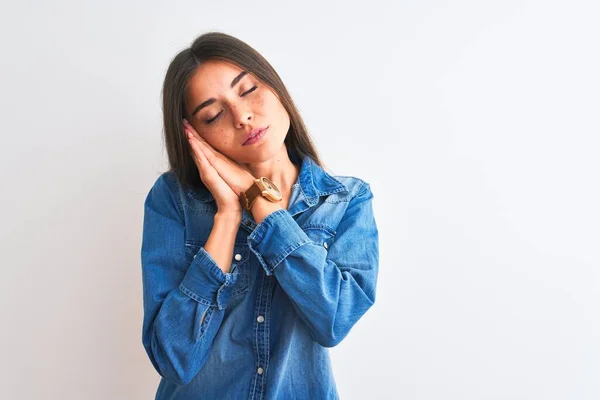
[{"left": 0, "top": 0, "right": 600, "bottom": 400}]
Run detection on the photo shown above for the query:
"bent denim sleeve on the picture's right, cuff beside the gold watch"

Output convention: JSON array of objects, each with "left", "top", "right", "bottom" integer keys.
[{"left": 248, "top": 182, "right": 379, "bottom": 347}]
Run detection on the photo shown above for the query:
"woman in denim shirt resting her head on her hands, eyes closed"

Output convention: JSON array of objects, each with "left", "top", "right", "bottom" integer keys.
[{"left": 141, "top": 32, "right": 379, "bottom": 399}]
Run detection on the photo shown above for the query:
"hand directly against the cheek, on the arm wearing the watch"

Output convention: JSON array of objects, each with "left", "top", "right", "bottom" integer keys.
[{"left": 183, "top": 119, "right": 255, "bottom": 196}]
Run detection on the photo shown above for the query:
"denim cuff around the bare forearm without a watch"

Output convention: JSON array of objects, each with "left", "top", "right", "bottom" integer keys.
[{"left": 179, "top": 247, "right": 238, "bottom": 310}]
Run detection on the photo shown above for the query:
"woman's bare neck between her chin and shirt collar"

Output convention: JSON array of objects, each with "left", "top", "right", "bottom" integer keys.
[{"left": 244, "top": 144, "right": 300, "bottom": 192}]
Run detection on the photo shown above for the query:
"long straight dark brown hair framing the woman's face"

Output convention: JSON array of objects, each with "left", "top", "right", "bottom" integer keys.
[{"left": 162, "top": 32, "right": 323, "bottom": 187}]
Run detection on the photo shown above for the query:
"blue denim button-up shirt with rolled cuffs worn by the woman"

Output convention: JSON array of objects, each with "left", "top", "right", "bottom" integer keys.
[{"left": 141, "top": 156, "right": 379, "bottom": 400}]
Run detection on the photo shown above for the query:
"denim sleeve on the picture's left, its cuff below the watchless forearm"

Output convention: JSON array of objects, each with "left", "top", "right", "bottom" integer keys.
[{"left": 141, "top": 174, "right": 238, "bottom": 385}]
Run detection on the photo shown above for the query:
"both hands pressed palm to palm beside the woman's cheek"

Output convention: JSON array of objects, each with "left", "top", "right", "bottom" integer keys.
[{"left": 183, "top": 119, "right": 255, "bottom": 216}]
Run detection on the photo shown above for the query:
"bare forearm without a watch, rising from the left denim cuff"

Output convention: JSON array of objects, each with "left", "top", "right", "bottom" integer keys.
[{"left": 204, "top": 212, "right": 242, "bottom": 273}]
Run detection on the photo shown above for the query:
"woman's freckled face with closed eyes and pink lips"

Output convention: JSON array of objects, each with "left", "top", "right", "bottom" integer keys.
[{"left": 186, "top": 60, "right": 290, "bottom": 163}]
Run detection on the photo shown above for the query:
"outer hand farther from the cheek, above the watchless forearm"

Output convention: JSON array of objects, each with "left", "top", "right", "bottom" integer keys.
[{"left": 185, "top": 130, "right": 242, "bottom": 219}]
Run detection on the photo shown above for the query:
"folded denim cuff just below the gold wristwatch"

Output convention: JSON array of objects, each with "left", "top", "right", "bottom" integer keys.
[{"left": 248, "top": 209, "right": 311, "bottom": 275}]
